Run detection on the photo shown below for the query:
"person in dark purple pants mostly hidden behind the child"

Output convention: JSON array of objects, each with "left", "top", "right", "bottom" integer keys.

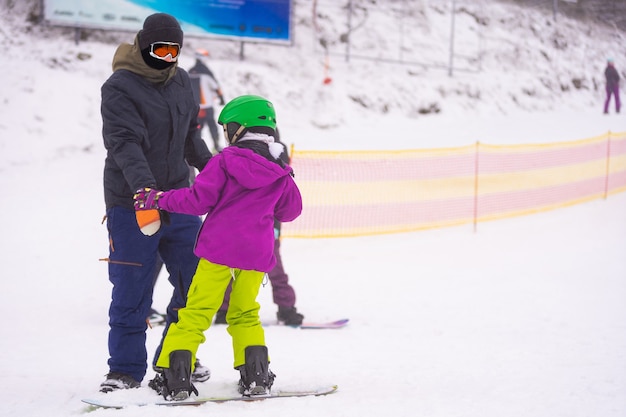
[{"left": 215, "top": 128, "right": 304, "bottom": 326}]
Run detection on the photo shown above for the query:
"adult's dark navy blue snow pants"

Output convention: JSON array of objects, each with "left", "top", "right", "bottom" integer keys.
[{"left": 107, "top": 207, "right": 201, "bottom": 382}]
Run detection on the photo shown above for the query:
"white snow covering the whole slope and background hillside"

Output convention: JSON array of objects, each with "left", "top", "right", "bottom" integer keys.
[{"left": 0, "top": 0, "right": 626, "bottom": 417}]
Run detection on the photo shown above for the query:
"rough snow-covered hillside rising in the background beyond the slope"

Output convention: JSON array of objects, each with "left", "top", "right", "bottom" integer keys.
[{"left": 3, "top": 0, "right": 626, "bottom": 126}]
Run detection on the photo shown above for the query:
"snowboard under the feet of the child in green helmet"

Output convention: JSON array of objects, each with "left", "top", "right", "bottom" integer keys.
[{"left": 81, "top": 385, "right": 338, "bottom": 409}]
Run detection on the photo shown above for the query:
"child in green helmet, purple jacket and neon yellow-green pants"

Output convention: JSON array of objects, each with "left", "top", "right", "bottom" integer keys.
[{"left": 135, "top": 95, "right": 302, "bottom": 400}]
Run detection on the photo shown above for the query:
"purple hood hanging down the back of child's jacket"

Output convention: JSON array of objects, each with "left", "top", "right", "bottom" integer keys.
[{"left": 220, "top": 146, "right": 292, "bottom": 189}]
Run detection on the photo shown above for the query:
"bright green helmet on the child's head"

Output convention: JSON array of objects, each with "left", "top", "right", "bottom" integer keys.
[{"left": 217, "top": 95, "right": 276, "bottom": 130}]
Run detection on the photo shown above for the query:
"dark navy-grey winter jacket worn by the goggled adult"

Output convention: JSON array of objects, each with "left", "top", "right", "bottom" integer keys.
[{"left": 101, "top": 42, "right": 211, "bottom": 208}]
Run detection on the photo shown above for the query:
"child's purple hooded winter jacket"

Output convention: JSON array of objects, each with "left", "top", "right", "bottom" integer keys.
[{"left": 159, "top": 146, "right": 302, "bottom": 272}]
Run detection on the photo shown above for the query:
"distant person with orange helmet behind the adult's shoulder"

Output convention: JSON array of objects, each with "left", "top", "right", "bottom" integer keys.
[{"left": 189, "top": 49, "right": 224, "bottom": 152}]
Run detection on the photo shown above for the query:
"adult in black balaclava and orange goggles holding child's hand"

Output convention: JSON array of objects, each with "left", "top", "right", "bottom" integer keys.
[{"left": 100, "top": 13, "right": 211, "bottom": 392}]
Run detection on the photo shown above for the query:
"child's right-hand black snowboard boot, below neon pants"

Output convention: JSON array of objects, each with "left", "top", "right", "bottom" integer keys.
[{"left": 237, "top": 346, "right": 276, "bottom": 397}]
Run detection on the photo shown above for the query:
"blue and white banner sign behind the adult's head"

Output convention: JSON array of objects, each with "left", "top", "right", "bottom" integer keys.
[{"left": 44, "top": 0, "right": 292, "bottom": 43}]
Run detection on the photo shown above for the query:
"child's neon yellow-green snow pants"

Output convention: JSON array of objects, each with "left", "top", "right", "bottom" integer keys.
[{"left": 156, "top": 258, "right": 265, "bottom": 369}]
